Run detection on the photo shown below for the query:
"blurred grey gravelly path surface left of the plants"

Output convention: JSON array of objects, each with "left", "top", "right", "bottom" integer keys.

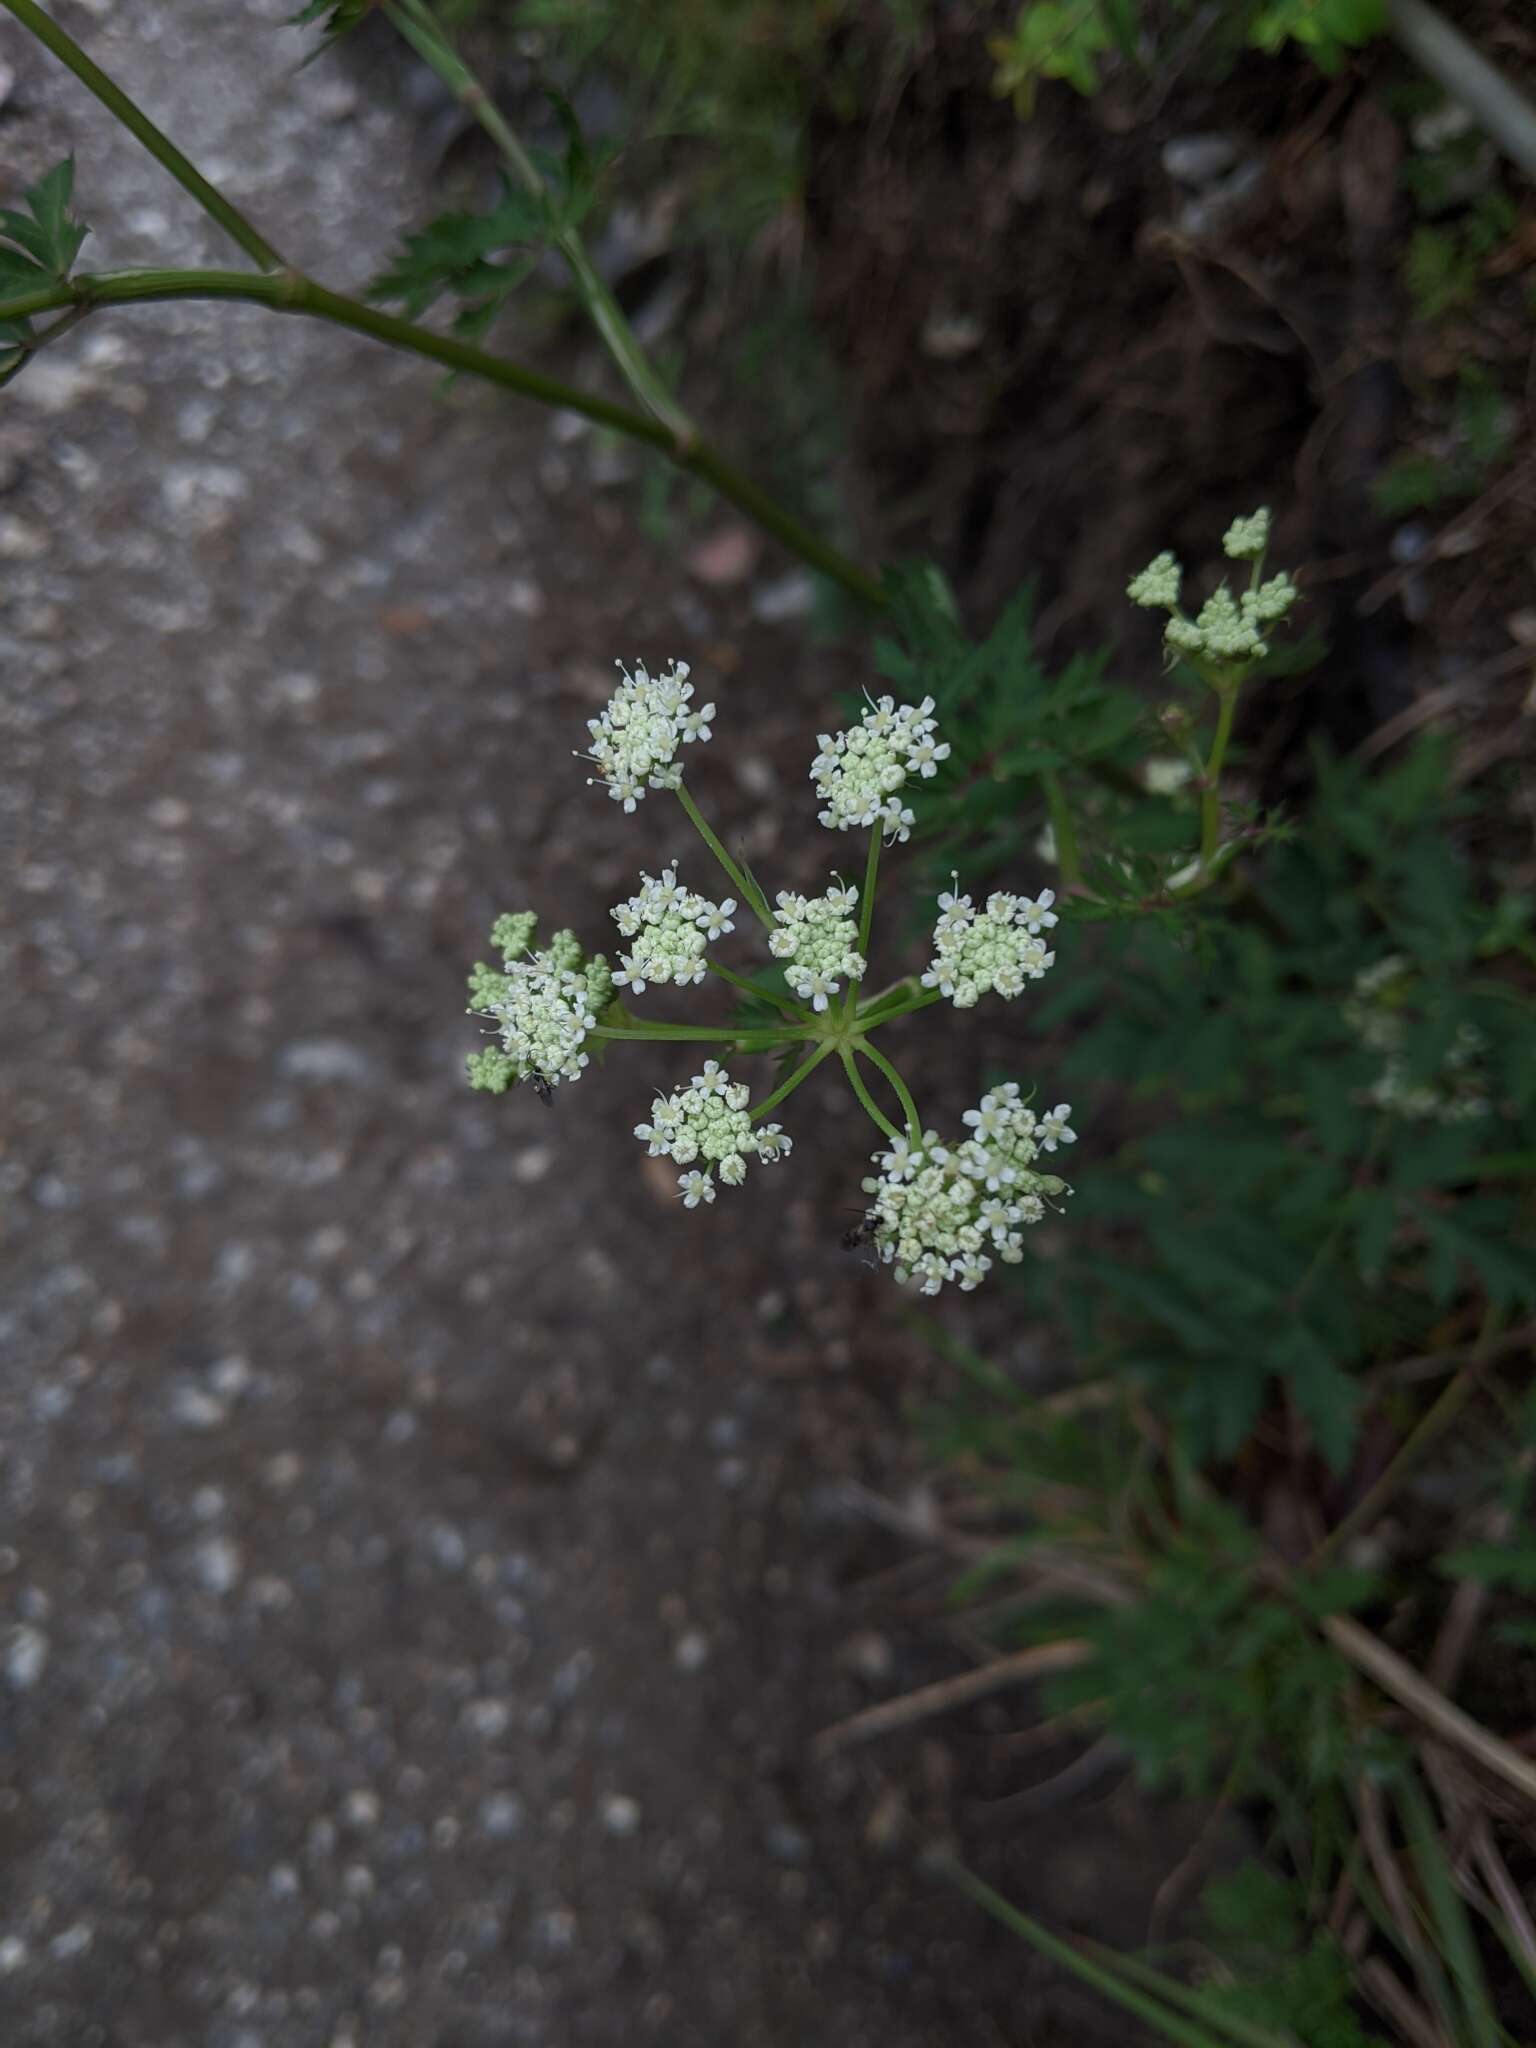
[{"left": 0, "top": 0, "right": 1139, "bottom": 2048}]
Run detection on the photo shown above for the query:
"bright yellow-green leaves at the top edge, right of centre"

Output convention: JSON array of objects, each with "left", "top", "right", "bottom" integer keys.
[{"left": 987, "top": 0, "right": 1386, "bottom": 115}]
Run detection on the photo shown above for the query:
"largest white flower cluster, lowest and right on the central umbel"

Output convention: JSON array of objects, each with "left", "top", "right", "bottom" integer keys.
[{"left": 864, "top": 1081, "right": 1077, "bottom": 1294}]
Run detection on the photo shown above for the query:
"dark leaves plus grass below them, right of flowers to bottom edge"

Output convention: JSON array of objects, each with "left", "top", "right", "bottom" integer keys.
[{"left": 909, "top": 524, "right": 1536, "bottom": 2048}]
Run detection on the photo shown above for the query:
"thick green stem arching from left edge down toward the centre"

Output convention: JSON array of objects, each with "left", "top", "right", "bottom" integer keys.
[{"left": 0, "top": 266, "right": 885, "bottom": 608}]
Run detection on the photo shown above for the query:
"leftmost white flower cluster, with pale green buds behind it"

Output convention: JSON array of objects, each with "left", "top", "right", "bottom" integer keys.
[{"left": 469, "top": 911, "right": 612, "bottom": 1096}]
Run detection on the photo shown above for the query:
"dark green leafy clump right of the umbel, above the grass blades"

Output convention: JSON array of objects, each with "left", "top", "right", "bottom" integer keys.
[{"left": 879, "top": 528, "right": 1536, "bottom": 1473}]
